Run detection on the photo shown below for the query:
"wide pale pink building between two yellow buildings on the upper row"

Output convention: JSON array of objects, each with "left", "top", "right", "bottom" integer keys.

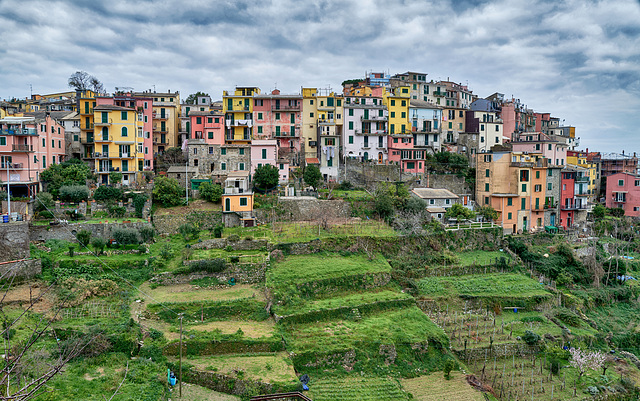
[{"left": 253, "top": 89, "right": 302, "bottom": 153}]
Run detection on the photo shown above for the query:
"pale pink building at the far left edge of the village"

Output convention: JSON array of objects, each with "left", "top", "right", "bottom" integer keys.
[{"left": 0, "top": 112, "right": 65, "bottom": 196}]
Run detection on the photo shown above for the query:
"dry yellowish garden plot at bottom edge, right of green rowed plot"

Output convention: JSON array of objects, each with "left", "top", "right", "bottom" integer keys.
[{"left": 400, "top": 372, "right": 485, "bottom": 401}]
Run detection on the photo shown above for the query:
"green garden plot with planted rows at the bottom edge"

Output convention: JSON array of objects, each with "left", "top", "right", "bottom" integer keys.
[{"left": 309, "top": 377, "right": 409, "bottom": 401}]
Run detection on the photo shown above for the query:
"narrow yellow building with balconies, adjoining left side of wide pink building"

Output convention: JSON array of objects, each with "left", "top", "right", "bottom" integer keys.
[{"left": 222, "top": 86, "right": 260, "bottom": 144}]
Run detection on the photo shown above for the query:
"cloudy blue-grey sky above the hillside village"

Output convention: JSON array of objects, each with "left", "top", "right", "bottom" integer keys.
[{"left": 0, "top": 0, "right": 640, "bottom": 153}]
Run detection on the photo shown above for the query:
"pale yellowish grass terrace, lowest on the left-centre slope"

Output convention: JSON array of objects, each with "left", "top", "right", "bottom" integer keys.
[{"left": 180, "top": 352, "right": 298, "bottom": 383}]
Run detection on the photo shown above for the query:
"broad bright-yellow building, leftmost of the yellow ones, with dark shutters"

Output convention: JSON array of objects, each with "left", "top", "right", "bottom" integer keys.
[{"left": 93, "top": 105, "right": 144, "bottom": 185}]
